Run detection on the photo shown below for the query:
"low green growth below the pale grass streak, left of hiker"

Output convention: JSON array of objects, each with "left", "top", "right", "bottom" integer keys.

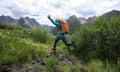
[{"left": 0, "top": 35, "right": 45, "bottom": 64}]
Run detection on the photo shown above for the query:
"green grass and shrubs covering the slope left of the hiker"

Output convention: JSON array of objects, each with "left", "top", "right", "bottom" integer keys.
[{"left": 0, "top": 22, "right": 50, "bottom": 65}]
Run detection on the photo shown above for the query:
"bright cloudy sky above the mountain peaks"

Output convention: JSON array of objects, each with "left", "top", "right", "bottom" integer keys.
[{"left": 0, "top": 0, "right": 120, "bottom": 25}]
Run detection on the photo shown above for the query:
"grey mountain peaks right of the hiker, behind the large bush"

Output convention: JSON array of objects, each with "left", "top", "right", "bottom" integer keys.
[{"left": 63, "top": 10, "right": 120, "bottom": 34}]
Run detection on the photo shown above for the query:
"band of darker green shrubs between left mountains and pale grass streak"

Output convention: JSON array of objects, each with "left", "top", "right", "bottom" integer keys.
[{"left": 0, "top": 22, "right": 50, "bottom": 43}]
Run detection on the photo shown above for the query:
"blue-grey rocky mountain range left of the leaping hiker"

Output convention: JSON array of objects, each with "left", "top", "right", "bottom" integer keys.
[{"left": 0, "top": 15, "right": 53, "bottom": 30}]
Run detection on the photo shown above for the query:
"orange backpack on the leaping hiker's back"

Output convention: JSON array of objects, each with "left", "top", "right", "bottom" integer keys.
[{"left": 58, "top": 20, "right": 69, "bottom": 34}]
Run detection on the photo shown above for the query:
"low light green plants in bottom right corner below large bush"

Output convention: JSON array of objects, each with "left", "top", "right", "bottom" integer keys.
[{"left": 86, "top": 59, "right": 119, "bottom": 72}]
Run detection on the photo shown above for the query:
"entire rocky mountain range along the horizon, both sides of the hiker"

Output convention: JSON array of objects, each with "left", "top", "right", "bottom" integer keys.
[{"left": 0, "top": 10, "right": 120, "bottom": 30}]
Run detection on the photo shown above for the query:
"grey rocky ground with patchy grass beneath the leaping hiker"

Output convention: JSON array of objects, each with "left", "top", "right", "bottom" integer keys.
[{"left": 0, "top": 54, "right": 86, "bottom": 72}]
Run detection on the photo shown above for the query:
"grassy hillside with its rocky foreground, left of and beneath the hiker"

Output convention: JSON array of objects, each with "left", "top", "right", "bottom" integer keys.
[{"left": 0, "top": 23, "right": 84, "bottom": 72}]
